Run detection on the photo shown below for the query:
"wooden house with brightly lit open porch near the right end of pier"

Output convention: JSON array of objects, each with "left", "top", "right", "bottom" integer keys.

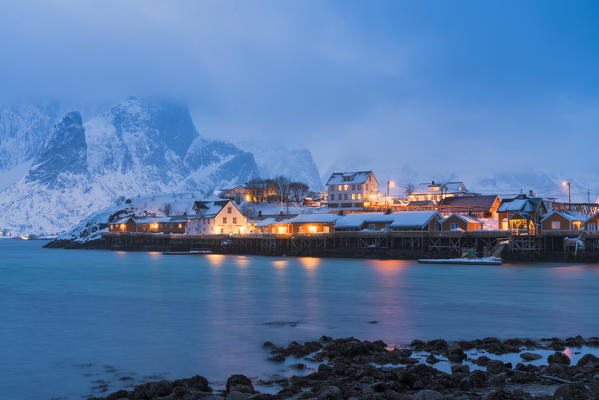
[{"left": 497, "top": 194, "right": 548, "bottom": 235}]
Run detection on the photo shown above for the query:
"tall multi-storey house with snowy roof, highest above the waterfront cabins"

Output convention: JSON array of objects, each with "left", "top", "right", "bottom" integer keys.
[{"left": 326, "top": 171, "right": 379, "bottom": 209}]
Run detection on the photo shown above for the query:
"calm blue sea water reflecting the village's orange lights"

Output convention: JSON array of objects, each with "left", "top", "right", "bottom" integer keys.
[{"left": 0, "top": 240, "right": 599, "bottom": 399}]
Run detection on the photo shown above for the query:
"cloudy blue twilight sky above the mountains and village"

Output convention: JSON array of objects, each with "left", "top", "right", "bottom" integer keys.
[{"left": 0, "top": 0, "right": 599, "bottom": 198}]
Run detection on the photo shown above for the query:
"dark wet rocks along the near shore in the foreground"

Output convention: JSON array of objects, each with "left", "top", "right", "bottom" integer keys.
[{"left": 91, "top": 336, "right": 599, "bottom": 400}]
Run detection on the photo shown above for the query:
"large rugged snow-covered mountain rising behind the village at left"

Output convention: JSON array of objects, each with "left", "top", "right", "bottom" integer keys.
[{"left": 0, "top": 98, "right": 278, "bottom": 235}]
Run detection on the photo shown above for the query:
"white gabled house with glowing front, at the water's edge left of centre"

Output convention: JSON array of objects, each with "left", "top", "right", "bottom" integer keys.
[{"left": 185, "top": 200, "right": 248, "bottom": 235}]
